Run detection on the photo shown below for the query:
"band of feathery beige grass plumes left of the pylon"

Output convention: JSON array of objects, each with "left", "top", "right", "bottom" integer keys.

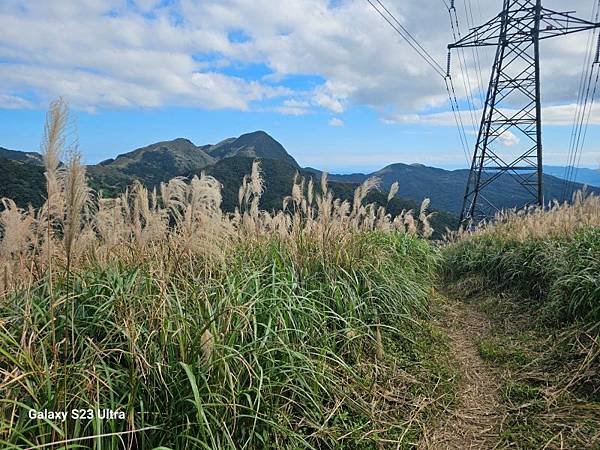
[{"left": 0, "top": 100, "right": 433, "bottom": 295}]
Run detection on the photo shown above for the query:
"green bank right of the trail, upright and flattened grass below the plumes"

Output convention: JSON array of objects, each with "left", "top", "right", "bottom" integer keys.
[{"left": 445, "top": 227, "right": 600, "bottom": 448}]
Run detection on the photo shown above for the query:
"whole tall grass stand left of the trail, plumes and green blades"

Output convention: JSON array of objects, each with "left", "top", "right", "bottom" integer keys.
[{"left": 0, "top": 100, "right": 448, "bottom": 449}]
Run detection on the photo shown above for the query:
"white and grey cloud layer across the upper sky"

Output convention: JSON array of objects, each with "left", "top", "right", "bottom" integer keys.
[{"left": 0, "top": 0, "right": 598, "bottom": 119}]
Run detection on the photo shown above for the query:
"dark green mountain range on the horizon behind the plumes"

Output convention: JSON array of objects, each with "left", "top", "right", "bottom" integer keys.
[{"left": 0, "top": 131, "right": 600, "bottom": 232}]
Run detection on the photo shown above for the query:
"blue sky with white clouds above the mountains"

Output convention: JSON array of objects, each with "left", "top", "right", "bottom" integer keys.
[{"left": 0, "top": 0, "right": 600, "bottom": 173}]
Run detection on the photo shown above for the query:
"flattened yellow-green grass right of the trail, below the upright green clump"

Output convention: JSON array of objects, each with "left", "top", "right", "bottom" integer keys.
[{"left": 450, "top": 284, "right": 600, "bottom": 449}]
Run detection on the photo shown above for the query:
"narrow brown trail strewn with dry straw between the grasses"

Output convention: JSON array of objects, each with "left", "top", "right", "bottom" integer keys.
[{"left": 419, "top": 300, "right": 503, "bottom": 450}]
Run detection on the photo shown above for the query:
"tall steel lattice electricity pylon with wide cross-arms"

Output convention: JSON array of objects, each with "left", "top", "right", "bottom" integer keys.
[{"left": 448, "top": 0, "right": 600, "bottom": 225}]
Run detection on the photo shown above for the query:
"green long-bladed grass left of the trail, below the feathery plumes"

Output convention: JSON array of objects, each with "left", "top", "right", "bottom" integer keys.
[{"left": 0, "top": 232, "right": 450, "bottom": 449}]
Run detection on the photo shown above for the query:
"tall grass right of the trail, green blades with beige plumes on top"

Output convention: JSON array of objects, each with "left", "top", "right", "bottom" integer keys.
[{"left": 444, "top": 193, "right": 600, "bottom": 323}]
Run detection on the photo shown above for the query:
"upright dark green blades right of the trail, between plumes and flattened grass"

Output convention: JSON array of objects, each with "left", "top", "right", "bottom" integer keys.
[{"left": 446, "top": 227, "right": 600, "bottom": 323}]
